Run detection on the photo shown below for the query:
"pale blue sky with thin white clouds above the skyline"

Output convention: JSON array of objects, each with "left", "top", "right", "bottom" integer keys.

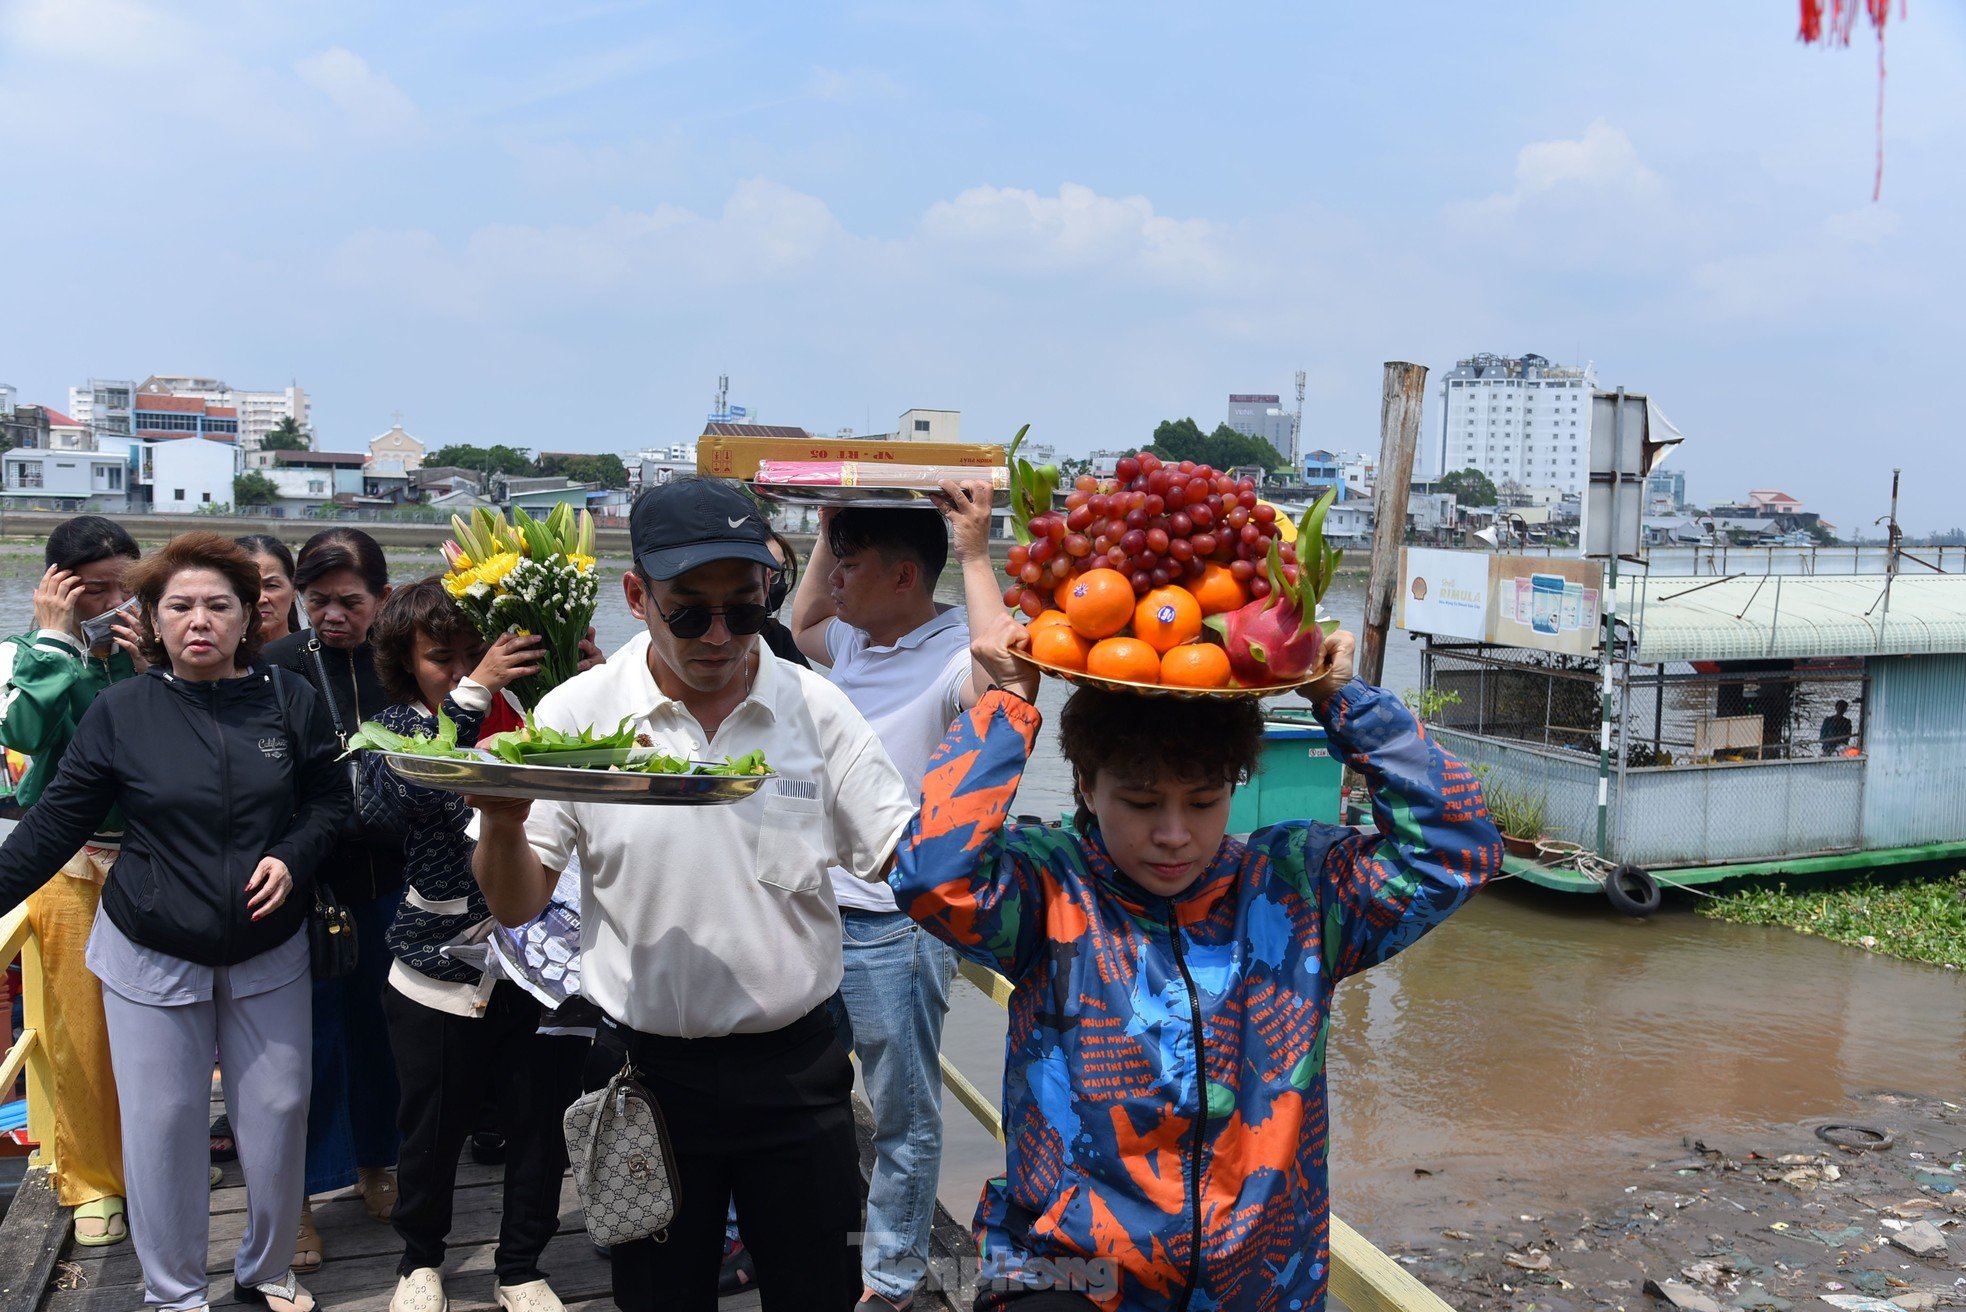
[{"left": 0, "top": 0, "right": 1966, "bottom": 531}]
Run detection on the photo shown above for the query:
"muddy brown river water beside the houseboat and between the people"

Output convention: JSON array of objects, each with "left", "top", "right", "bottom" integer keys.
[{"left": 0, "top": 555, "right": 1966, "bottom": 1243}]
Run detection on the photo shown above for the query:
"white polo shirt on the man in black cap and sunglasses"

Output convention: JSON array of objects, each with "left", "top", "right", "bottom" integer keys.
[{"left": 525, "top": 633, "right": 916, "bottom": 1039}]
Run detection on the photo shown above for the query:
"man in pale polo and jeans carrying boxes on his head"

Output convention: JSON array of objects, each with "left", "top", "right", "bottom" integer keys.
[{"left": 782, "top": 484, "right": 1003, "bottom": 1312}]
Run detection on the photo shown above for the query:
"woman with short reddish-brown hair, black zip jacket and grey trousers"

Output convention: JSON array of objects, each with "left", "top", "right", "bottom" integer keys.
[{"left": 0, "top": 533, "right": 348, "bottom": 1312}]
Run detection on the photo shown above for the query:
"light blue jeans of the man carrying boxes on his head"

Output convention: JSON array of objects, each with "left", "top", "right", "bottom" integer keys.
[{"left": 832, "top": 909, "right": 955, "bottom": 1298}]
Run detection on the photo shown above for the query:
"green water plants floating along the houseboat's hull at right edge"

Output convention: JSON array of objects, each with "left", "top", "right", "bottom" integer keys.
[{"left": 1699, "top": 871, "right": 1966, "bottom": 970}]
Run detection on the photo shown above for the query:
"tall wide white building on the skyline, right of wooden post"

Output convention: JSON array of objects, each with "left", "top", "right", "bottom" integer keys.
[{"left": 1435, "top": 352, "right": 1596, "bottom": 492}]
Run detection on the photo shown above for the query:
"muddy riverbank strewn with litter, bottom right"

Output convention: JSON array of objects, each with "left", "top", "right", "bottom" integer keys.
[{"left": 1388, "top": 1094, "right": 1966, "bottom": 1312}]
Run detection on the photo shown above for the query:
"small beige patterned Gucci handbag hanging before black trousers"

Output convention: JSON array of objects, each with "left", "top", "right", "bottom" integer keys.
[{"left": 566, "top": 1064, "right": 676, "bottom": 1245}]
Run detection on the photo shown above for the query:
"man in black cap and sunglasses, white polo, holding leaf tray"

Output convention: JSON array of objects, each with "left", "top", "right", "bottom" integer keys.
[{"left": 474, "top": 478, "right": 914, "bottom": 1312}]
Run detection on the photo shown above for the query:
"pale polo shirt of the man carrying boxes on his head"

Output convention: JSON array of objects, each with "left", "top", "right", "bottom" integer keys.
[{"left": 826, "top": 608, "right": 969, "bottom": 911}]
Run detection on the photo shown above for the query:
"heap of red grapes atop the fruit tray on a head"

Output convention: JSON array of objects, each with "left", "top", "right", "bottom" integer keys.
[{"left": 1003, "top": 450, "right": 1298, "bottom": 616}]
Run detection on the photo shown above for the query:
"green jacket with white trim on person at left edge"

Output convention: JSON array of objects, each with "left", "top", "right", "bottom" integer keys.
[{"left": 0, "top": 629, "right": 136, "bottom": 834}]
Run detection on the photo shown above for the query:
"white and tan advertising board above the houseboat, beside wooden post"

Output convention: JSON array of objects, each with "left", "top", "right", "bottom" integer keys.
[{"left": 1394, "top": 547, "right": 1602, "bottom": 655}]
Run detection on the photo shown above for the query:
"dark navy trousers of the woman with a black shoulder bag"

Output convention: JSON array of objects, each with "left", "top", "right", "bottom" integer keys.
[{"left": 307, "top": 885, "right": 403, "bottom": 1196}]
